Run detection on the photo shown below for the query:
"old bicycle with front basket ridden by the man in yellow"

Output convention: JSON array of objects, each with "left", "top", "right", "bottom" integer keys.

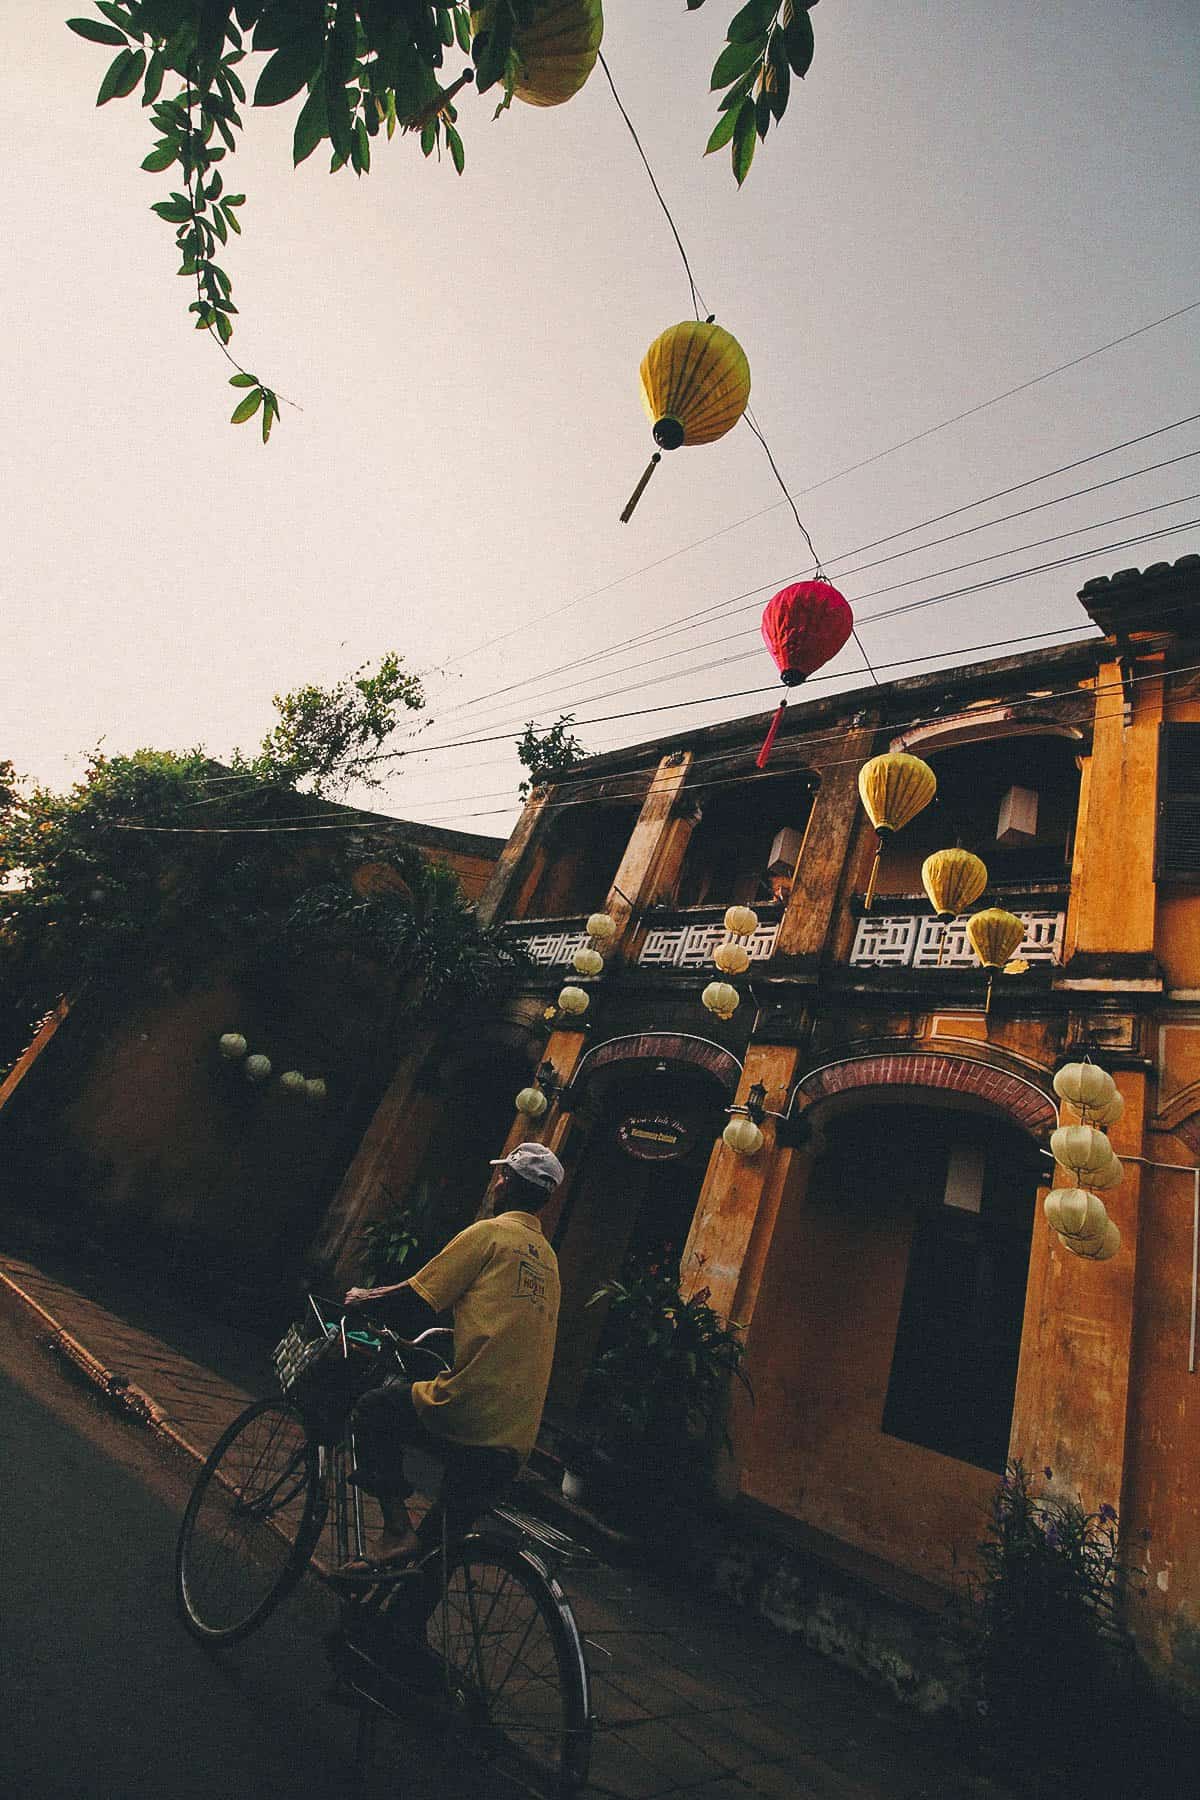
[{"left": 175, "top": 1296, "right": 594, "bottom": 1796}]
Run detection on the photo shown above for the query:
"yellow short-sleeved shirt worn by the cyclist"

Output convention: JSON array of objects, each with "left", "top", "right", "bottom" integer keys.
[{"left": 408, "top": 1213, "right": 560, "bottom": 1456}]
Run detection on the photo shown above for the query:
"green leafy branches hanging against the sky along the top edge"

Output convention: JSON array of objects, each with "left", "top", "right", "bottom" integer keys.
[{"left": 67, "top": 0, "right": 817, "bottom": 430}]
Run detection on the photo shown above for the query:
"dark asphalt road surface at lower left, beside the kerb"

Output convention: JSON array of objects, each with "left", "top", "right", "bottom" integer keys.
[{"left": 0, "top": 1321, "right": 489, "bottom": 1800}]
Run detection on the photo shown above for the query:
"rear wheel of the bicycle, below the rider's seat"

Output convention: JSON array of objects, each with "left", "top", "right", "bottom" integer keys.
[{"left": 426, "top": 1537, "right": 592, "bottom": 1796}]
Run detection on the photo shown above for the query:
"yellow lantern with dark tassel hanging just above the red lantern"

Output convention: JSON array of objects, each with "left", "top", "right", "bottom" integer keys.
[{"left": 621, "top": 319, "right": 750, "bottom": 526}]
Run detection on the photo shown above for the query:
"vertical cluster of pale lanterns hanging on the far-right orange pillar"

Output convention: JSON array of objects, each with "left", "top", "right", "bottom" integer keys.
[{"left": 1042, "top": 1062, "right": 1124, "bottom": 1262}]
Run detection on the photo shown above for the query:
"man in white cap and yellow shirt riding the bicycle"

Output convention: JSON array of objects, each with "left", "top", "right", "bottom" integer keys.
[{"left": 342, "top": 1143, "right": 563, "bottom": 1580}]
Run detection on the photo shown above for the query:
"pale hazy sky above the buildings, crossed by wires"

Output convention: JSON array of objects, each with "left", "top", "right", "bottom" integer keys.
[{"left": 0, "top": 0, "right": 1200, "bottom": 833}]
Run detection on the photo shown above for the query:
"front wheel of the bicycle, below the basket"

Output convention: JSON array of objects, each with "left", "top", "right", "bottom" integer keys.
[{"left": 175, "top": 1400, "right": 326, "bottom": 1643}]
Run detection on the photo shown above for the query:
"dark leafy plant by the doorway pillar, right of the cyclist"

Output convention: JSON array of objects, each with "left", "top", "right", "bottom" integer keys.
[{"left": 585, "top": 1262, "right": 750, "bottom": 1516}]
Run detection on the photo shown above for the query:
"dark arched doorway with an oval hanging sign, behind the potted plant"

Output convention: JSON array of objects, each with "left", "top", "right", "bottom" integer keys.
[{"left": 547, "top": 1055, "right": 736, "bottom": 1424}]
